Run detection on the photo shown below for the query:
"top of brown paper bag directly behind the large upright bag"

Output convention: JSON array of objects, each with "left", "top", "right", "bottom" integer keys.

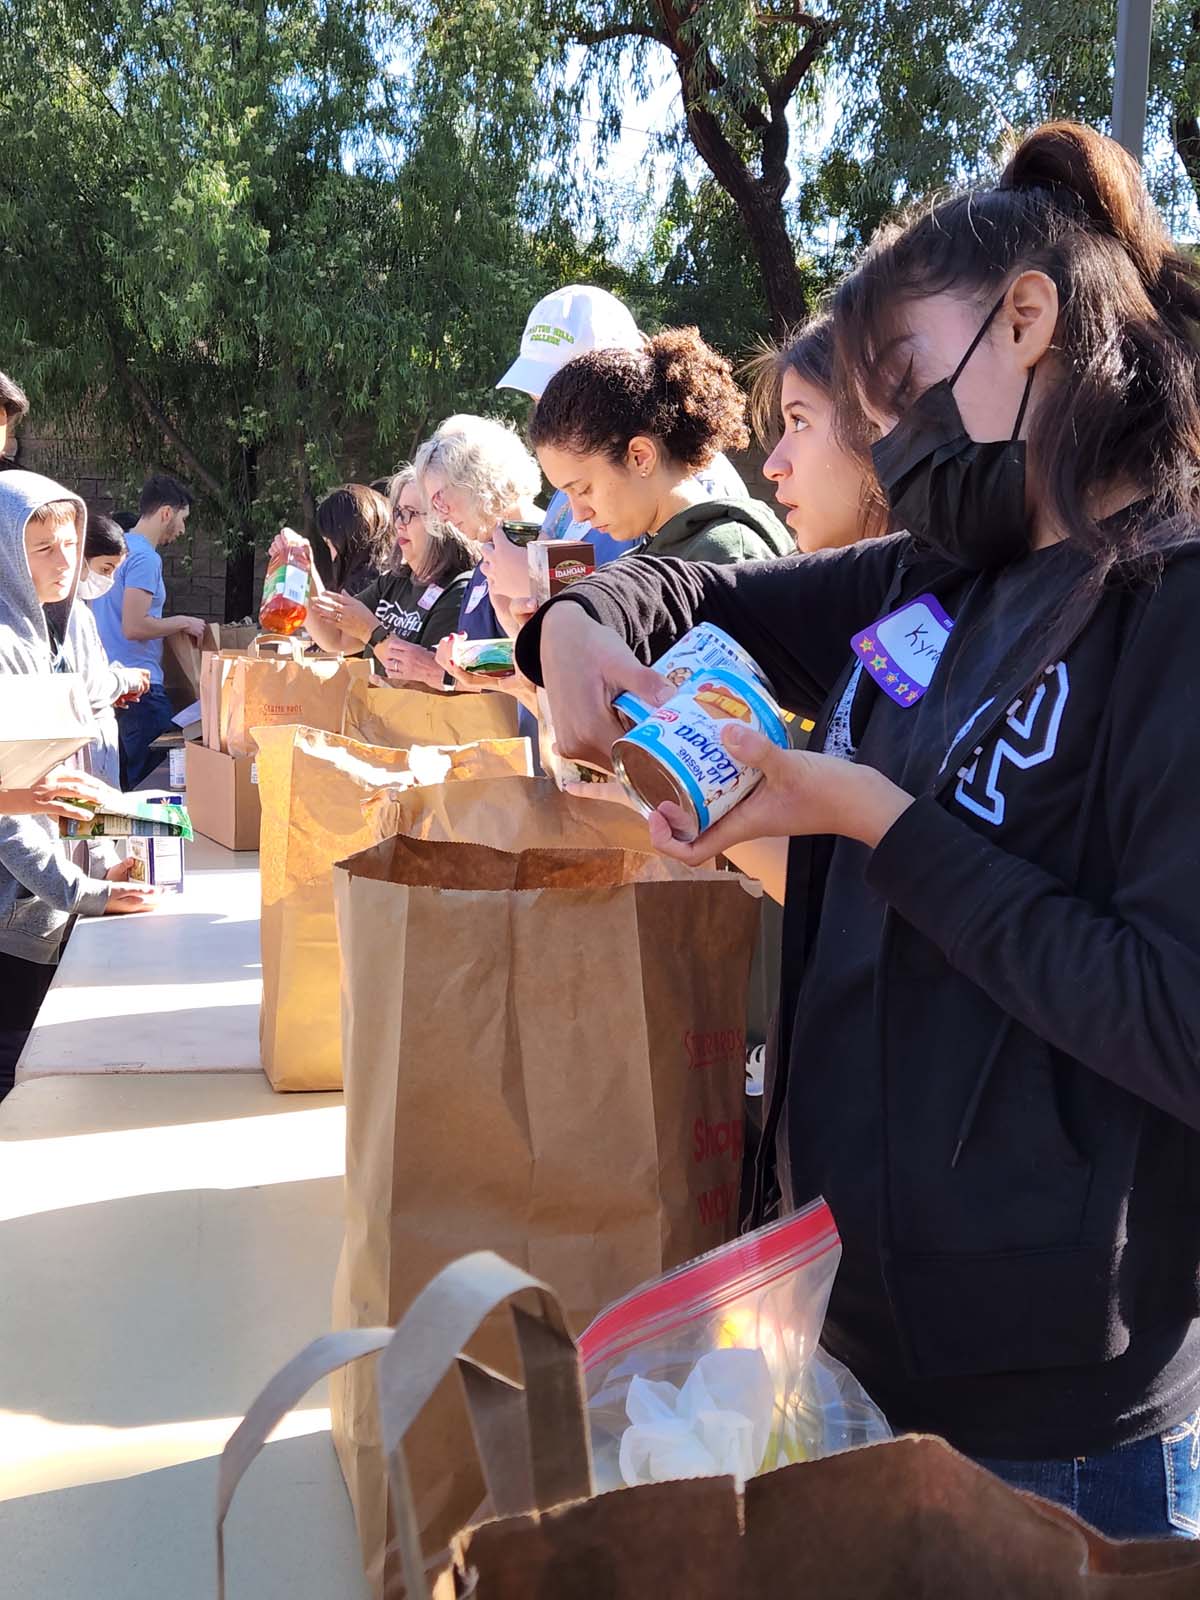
[{"left": 365, "top": 778, "right": 666, "bottom": 859}]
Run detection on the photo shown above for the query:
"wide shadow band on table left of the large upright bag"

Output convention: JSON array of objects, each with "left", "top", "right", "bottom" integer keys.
[{"left": 0, "top": 1164, "right": 342, "bottom": 1427}]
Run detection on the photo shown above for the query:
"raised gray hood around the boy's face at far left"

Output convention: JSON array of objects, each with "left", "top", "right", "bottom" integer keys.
[{"left": 0, "top": 472, "right": 88, "bottom": 670}]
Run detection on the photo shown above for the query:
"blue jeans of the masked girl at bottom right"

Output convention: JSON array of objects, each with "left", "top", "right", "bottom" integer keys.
[{"left": 979, "top": 1411, "right": 1200, "bottom": 1539}]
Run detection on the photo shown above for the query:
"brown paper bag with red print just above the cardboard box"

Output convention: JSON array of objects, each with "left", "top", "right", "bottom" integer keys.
[{"left": 200, "top": 638, "right": 371, "bottom": 755}]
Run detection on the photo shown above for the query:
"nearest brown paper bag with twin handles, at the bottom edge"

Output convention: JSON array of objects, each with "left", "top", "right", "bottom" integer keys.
[{"left": 216, "top": 1251, "right": 1200, "bottom": 1600}]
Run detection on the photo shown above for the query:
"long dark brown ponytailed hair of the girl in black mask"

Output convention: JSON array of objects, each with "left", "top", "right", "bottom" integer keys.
[{"left": 834, "top": 122, "right": 1200, "bottom": 582}]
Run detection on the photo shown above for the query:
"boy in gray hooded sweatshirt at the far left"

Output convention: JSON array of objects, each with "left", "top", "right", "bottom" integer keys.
[{"left": 0, "top": 472, "right": 157, "bottom": 1096}]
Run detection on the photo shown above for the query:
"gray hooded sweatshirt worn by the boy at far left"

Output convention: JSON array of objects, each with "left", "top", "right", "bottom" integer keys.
[{"left": 0, "top": 472, "right": 110, "bottom": 963}]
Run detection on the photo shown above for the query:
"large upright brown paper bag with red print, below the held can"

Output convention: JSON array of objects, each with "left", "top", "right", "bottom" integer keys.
[{"left": 333, "top": 832, "right": 758, "bottom": 1600}]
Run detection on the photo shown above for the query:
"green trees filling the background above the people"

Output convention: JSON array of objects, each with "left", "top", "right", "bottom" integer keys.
[{"left": 0, "top": 0, "right": 1200, "bottom": 576}]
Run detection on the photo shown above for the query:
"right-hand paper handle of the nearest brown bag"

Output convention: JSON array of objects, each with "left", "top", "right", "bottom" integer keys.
[{"left": 376, "top": 1250, "right": 594, "bottom": 1600}]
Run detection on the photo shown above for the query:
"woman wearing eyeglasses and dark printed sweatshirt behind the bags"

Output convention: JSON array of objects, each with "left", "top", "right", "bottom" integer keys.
[{"left": 299, "top": 466, "right": 480, "bottom": 688}]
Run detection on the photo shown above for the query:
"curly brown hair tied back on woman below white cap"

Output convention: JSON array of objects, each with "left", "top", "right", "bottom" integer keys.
[{"left": 530, "top": 328, "right": 750, "bottom": 472}]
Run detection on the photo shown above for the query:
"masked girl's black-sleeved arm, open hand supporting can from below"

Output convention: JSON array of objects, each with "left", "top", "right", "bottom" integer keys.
[{"left": 650, "top": 562, "right": 1200, "bottom": 1130}]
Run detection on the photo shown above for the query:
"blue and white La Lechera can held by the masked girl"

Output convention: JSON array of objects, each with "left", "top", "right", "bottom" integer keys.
[{"left": 613, "top": 662, "right": 789, "bottom": 840}]
